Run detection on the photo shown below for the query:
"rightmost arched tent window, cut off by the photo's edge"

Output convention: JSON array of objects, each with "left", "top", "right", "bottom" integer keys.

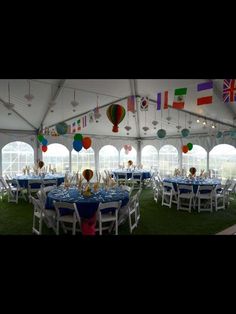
[{"left": 209, "top": 144, "right": 236, "bottom": 179}]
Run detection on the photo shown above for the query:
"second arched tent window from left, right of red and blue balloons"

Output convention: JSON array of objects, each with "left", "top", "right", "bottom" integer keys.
[{"left": 43, "top": 144, "right": 70, "bottom": 173}]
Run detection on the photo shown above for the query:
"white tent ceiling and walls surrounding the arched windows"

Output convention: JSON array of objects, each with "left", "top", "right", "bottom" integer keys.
[{"left": 0, "top": 79, "right": 236, "bottom": 172}]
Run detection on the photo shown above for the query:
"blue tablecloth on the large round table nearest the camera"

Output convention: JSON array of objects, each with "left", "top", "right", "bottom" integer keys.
[{"left": 46, "top": 188, "right": 129, "bottom": 219}]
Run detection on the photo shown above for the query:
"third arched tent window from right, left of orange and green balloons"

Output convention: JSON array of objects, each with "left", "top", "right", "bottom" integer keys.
[{"left": 159, "top": 145, "right": 179, "bottom": 176}]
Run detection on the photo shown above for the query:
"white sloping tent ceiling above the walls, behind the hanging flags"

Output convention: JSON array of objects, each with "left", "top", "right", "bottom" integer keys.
[{"left": 0, "top": 79, "right": 236, "bottom": 137}]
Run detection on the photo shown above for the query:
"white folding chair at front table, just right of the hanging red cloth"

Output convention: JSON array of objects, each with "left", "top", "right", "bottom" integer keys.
[{"left": 98, "top": 201, "right": 122, "bottom": 235}]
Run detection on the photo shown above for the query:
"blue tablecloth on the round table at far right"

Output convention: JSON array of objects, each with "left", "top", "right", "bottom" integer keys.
[{"left": 163, "top": 177, "right": 221, "bottom": 194}]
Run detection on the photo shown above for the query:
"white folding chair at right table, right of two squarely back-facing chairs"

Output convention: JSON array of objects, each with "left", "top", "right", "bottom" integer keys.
[{"left": 196, "top": 185, "right": 214, "bottom": 212}]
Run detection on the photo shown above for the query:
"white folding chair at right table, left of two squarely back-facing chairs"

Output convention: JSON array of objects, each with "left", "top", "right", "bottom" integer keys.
[{"left": 177, "top": 184, "right": 194, "bottom": 213}]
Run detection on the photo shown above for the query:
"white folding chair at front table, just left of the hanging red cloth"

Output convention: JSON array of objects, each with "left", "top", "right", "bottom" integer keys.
[{"left": 53, "top": 201, "right": 81, "bottom": 235}]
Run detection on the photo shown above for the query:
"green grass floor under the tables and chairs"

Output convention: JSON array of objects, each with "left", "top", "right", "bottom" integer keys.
[{"left": 0, "top": 189, "right": 236, "bottom": 235}]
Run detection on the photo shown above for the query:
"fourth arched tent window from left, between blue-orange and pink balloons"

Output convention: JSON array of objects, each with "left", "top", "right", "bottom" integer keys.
[{"left": 99, "top": 145, "right": 119, "bottom": 171}]
